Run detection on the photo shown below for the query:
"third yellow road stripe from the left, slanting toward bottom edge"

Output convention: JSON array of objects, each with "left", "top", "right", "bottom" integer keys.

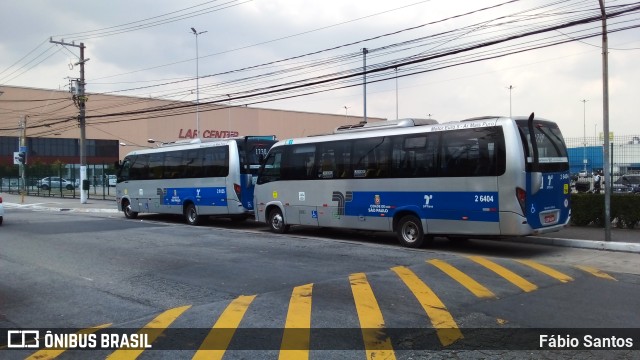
[{"left": 193, "top": 295, "right": 256, "bottom": 359}]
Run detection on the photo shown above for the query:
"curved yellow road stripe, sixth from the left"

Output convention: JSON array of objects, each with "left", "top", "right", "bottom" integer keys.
[{"left": 391, "top": 266, "right": 463, "bottom": 346}]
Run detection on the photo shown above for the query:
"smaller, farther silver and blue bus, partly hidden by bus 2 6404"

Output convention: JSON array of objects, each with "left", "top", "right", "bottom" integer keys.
[{"left": 116, "top": 136, "right": 276, "bottom": 225}]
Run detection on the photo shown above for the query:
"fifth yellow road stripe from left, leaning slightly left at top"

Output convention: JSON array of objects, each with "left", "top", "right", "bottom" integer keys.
[{"left": 349, "top": 273, "right": 396, "bottom": 359}]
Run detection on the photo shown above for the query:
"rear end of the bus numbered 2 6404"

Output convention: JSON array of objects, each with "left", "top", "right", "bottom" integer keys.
[{"left": 518, "top": 118, "right": 571, "bottom": 229}]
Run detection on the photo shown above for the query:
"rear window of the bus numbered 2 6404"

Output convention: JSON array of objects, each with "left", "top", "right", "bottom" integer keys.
[{"left": 516, "top": 120, "right": 569, "bottom": 172}]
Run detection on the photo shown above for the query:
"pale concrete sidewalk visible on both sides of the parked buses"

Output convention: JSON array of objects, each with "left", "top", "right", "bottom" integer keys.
[{"left": 0, "top": 193, "right": 640, "bottom": 253}]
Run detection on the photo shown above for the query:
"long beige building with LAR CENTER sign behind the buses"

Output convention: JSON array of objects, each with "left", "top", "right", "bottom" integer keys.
[{"left": 0, "top": 86, "right": 384, "bottom": 164}]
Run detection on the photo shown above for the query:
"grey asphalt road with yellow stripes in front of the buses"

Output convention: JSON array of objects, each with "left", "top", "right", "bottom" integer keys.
[{"left": 0, "top": 209, "right": 640, "bottom": 359}]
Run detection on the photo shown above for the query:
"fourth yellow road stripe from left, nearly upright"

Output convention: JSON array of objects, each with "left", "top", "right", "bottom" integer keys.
[{"left": 279, "top": 284, "right": 313, "bottom": 360}]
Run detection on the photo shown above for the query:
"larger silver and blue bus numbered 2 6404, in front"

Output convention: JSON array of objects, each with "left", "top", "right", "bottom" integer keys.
[{"left": 254, "top": 114, "right": 571, "bottom": 247}]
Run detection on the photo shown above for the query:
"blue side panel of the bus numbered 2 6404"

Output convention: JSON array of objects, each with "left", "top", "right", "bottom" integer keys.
[{"left": 342, "top": 191, "right": 500, "bottom": 222}]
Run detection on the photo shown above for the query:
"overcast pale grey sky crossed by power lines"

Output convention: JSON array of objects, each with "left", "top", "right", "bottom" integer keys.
[{"left": 0, "top": 0, "right": 640, "bottom": 137}]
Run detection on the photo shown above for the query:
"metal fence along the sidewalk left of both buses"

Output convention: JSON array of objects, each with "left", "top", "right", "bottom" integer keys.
[{"left": 0, "top": 164, "right": 116, "bottom": 200}]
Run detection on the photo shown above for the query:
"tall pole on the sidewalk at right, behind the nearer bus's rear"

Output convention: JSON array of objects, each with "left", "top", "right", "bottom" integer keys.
[{"left": 598, "top": 0, "right": 612, "bottom": 241}]
